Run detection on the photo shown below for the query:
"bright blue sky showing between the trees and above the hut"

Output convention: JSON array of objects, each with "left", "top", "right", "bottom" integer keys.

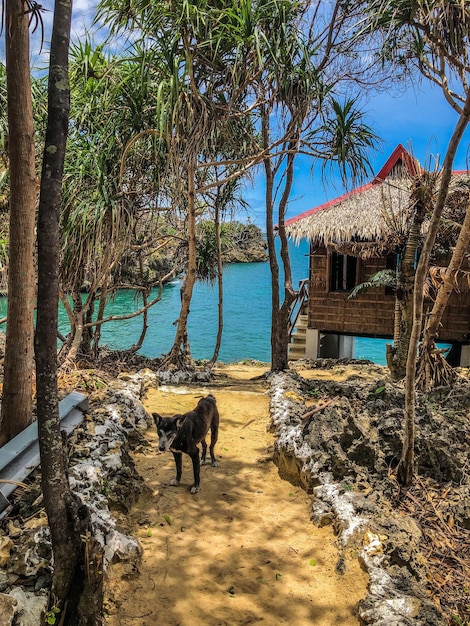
[{"left": 0, "top": 0, "right": 470, "bottom": 227}]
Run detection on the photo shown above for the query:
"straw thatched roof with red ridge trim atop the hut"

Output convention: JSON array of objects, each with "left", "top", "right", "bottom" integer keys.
[{"left": 286, "top": 145, "right": 468, "bottom": 256}]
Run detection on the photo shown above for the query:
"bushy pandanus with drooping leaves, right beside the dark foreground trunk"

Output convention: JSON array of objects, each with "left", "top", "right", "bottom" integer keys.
[{"left": 60, "top": 44, "right": 176, "bottom": 366}]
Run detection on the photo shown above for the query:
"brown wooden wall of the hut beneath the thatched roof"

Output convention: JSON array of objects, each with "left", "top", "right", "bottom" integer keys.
[{"left": 308, "top": 248, "right": 470, "bottom": 343}]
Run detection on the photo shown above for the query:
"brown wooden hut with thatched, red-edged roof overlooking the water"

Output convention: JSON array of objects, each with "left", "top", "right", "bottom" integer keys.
[{"left": 286, "top": 145, "right": 470, "bottom": 365}]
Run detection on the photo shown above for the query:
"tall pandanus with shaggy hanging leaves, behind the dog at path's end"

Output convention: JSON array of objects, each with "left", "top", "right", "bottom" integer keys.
[{"left": 101, "top": 2, "right": 268, "bottom": 367}]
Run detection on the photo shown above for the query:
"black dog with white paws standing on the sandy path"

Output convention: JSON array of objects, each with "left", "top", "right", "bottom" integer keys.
[{"left": 152, "top": 395, "right": 219, "bottom": 493}]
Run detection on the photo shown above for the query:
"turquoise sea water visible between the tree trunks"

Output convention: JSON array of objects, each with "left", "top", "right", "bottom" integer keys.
[{"left": 0, "top": 241, "right": 396, "bottom": 365}]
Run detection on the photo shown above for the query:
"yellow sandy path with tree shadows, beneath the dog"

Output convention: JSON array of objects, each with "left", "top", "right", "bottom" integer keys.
[{"left": 106, "top": 372, "right": 367, "bottom": 626}]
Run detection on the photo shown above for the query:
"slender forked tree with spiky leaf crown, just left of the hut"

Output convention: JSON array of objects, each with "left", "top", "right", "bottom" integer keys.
[{"left": 252, "top": 3, "right": 377, "bottom": 371}]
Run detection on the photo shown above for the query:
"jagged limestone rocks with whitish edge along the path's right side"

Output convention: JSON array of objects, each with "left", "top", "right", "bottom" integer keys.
[{"left": 270, "top": 372, "right": 454, "bottom": 626}]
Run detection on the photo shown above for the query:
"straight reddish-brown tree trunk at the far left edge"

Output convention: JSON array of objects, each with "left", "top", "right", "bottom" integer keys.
[{"left": 0, "top": 0, "right": 37, "bottom": 445}]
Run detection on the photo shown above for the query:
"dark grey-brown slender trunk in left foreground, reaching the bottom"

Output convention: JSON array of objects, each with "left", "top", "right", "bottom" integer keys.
[{"left": 35, "top": 0, "right": 80, "bottom": 612}]
